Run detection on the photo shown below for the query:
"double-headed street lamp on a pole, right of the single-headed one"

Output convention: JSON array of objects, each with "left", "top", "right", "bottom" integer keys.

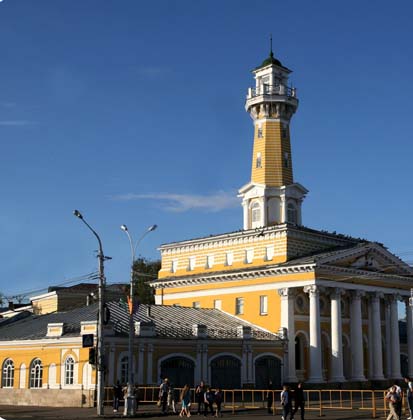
[{"left": 120, "top": 225, "right": 158, "bottom": 416}]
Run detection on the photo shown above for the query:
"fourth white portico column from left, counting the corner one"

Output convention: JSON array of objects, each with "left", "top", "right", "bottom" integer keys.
[{"left": 350, "top": 290, "right": 366, "bottom": 381}]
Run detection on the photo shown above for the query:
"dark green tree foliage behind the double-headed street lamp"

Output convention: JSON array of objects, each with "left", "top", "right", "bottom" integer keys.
[{"left": 133, "top": 257, "right": 161, "bottom": 304}]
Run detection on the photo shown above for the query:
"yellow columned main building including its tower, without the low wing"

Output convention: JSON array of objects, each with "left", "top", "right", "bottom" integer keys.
[{"left": 151, "top": 51, "right": 413, "bottom": 383}]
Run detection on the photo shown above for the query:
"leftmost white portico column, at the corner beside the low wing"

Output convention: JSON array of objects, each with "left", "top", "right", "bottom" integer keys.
[{"left": 278, "top": 288, "right": 298, "bottom": 382}]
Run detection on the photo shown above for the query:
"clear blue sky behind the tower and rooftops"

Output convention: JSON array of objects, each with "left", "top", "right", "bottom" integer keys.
[{"left": 0, "top": 0, "right": 413, "bottom": 295}]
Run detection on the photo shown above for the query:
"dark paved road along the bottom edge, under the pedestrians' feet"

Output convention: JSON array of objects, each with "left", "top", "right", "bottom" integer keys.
[{"left": 0, "top": 406, "right": 376, "bottom": 420}]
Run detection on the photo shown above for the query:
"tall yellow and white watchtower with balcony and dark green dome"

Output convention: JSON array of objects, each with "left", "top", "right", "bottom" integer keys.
[{"left": 239, "top": 47, "right": 308, "bottom": 229}]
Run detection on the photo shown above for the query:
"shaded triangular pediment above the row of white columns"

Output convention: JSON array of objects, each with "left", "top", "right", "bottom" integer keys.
[{"left": 317, "top": 242, "right": 413, "bottom": 276}]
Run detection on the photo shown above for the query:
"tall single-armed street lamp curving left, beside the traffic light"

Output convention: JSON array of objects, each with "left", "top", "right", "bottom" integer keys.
[{"left": 73, "top": 210, "right": 105, "bottom": 416}]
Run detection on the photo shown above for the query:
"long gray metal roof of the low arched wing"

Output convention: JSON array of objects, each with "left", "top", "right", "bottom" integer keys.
[{"left": 0, "top": 301, "right": 280, "bottom": 341}]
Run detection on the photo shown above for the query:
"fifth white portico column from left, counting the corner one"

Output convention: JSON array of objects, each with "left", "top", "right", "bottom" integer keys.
[{"left": 370, "top": 293, "right": 384, "bottom": 380}]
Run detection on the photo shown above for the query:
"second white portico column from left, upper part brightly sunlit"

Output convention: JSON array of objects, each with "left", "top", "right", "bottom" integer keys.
[{"left": 304, "top": 284, "right": 324, "bottom": 383}]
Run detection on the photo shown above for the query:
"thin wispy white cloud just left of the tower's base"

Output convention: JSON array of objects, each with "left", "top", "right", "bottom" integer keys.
[{"left": 112, "top": 191, "right": 240, "bottom": 212}]
